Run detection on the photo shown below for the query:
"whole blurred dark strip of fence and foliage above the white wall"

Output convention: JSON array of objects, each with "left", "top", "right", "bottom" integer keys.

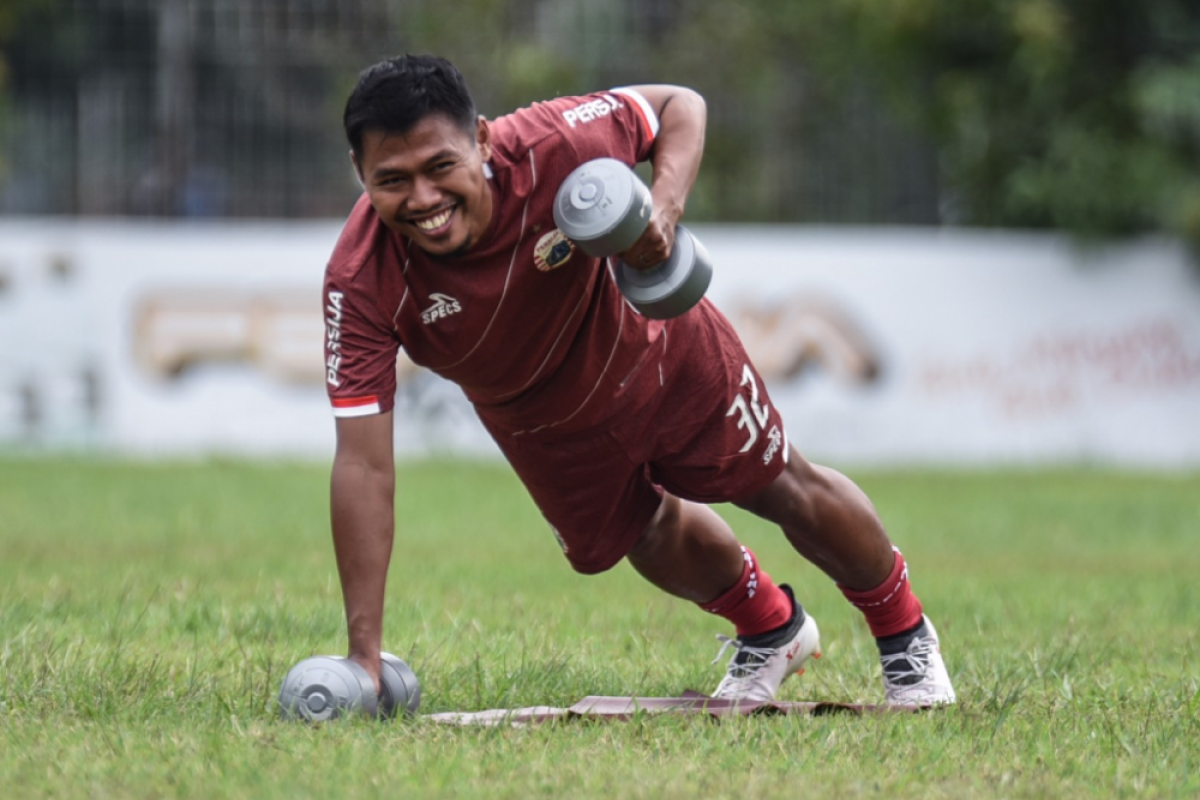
[{"left": 0, "top": 0, "right": 1200, "bottom": 242}]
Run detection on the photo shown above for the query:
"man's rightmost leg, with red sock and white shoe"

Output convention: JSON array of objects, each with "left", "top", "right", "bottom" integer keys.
[{"left": 738, "top": 449, "right": 955, "bottom": 704}]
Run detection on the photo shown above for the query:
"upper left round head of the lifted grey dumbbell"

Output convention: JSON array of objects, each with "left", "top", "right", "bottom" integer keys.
[{"left": 554, "top": 158, "right": 650, "bottom": 258}]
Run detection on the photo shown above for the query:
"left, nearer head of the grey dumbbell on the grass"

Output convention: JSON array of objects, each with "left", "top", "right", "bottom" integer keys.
[{"left": 278, "top": 656, "right": 379, "bottom": 722}]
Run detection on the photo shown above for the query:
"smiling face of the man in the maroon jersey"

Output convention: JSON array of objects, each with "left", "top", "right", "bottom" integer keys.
[{"left": 355, "top": 114, "right": 492, "bottom": 255}]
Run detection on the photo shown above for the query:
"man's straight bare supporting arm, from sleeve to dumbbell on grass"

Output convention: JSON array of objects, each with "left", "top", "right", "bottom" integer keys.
[{"left": 330, "top": 411, "right": 396, "bottom": 688}]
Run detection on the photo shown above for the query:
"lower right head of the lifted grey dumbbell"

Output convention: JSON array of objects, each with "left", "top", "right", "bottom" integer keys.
[{"left": 616, "top": 225, "right": 713, "bottom": 319}]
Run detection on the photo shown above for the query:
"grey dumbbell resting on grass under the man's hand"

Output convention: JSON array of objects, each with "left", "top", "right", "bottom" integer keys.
[{"left": 278, "top": 652, "right": 421, "bottom": 722}]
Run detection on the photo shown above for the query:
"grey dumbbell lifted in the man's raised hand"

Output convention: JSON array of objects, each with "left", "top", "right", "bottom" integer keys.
[{"left": 554, "top": 158, "right": 713, "bottom": 319}]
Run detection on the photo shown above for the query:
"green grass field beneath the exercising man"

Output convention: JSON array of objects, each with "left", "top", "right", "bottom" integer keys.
[{"left": 0, "top": 458, "right": 1200, "bottom": 799}]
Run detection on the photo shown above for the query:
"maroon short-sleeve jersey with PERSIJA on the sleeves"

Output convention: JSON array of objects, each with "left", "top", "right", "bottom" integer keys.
[{"left": 324, "top": 89, "right": 662, "bottom": 434}]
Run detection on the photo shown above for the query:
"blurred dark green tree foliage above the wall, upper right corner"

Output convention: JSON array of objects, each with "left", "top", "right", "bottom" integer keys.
[{"left": 811, "top": 0, "right": 1200, "bottom": 242}]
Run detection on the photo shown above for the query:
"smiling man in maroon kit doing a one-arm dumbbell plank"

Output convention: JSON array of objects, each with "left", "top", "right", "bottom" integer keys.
[{"left": 324, "top": 56, "right": 954, "bottom": 704}]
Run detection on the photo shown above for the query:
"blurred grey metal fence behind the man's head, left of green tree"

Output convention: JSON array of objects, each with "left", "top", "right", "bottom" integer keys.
[{"left": 0, "top": 0, "right": 940, "bottom": 223}]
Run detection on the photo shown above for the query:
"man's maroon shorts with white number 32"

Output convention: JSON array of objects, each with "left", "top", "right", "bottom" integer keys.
[{"left": 472, "top": 302, "right": 787, "bottom": 573}]
